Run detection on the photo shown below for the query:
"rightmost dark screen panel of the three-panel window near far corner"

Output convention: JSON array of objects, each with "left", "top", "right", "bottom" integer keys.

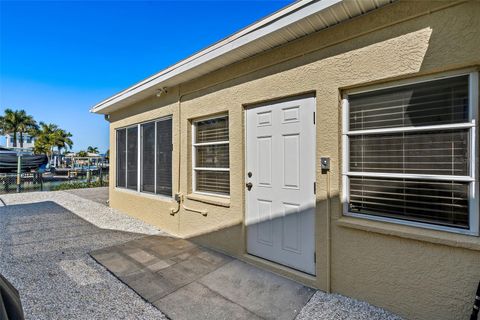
[{"left": 156, "top": 119, "right": 172, "bottom": 197}]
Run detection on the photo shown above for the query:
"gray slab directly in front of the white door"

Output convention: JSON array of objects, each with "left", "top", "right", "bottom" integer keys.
[{"left": 198, "top": 260, "right": 315, "bottom": 320}]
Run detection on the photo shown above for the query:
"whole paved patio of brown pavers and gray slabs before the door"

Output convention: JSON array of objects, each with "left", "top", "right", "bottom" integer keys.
[{"left": 91, "top": 236, "right": 315, "bottom": 320}]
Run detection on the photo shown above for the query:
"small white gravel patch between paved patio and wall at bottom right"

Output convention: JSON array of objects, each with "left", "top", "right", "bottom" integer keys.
[{"left": 296, "top": 291, "right": 402, "bottom": 320}]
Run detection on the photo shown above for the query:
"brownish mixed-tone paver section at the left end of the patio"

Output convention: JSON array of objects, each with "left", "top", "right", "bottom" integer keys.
[{"left": 90, "top": 236, "right": 231, "bottom": 302}]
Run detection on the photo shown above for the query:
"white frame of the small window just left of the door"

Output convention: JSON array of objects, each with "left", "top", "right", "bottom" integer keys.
[{"left": 191, "top": 114, "right": 230, "bottom": 199}]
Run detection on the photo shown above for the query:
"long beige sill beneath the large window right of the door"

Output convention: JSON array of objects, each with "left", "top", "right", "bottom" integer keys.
[{"left": 335, "top": 216, "right": 480, "bottom": 251}]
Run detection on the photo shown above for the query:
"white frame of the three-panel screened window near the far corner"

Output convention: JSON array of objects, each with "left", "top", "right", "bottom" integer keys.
[{"left": 115, "top": 115, "right": 173, "bottom": 200}]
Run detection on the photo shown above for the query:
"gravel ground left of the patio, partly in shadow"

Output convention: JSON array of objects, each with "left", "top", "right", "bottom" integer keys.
[{"left": 0, "top": 192, "right": 165, "bottom": 319}]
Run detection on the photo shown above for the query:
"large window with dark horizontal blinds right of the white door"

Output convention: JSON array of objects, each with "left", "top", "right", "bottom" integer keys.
[{"left": 343, "top": 73, "right": 479, "bottom": 234}]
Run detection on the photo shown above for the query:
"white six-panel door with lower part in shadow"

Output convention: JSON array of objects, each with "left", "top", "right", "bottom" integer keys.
[{"left": 245, "top": 97, "right": 316, "bottom": 274}]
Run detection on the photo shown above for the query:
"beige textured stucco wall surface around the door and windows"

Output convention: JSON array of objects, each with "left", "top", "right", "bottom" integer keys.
[{"left": 110, "top": 1, "right": 480, "bottom": 319}]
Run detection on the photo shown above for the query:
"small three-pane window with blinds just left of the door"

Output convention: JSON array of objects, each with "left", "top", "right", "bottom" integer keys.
[{"left": 192, "top": 116, "right": 230, "bottom": 196}]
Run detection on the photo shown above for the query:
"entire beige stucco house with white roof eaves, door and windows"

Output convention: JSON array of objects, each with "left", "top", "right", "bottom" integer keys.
[{"left": 92, "top": 0, "right": 480, "bottom": 319}]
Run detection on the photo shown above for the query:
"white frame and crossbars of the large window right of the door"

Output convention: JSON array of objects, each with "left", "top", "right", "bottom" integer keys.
[{"left": 342, "top": 69, "right": 480, "bottom": 236}]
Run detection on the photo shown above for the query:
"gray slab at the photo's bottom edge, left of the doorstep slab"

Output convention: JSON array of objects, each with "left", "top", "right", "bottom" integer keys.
[{"left": 153, "top": 282, "right": 261, "bottom": 320}]
